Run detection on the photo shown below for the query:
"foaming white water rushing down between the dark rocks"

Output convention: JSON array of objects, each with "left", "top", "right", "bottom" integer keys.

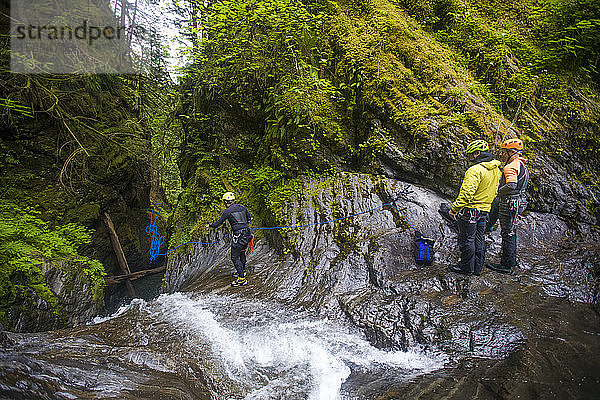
[{"left": 144, "top": 293, "right": 445, "bottom": 400}]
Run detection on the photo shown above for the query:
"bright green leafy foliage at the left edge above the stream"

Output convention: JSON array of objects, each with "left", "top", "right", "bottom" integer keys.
[{"left": 0, "top": 199, "right": 106, "bottom": 324}]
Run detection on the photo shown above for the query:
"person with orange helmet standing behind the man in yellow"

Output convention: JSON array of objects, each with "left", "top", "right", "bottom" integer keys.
[{"left": 486, "top": 138, "right": 529, "bottom": 274}]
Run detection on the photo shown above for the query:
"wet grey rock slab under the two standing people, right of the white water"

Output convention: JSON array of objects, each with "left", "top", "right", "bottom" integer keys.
[{"left": 167, "top": 174, "right": 600, "bottom": 398}]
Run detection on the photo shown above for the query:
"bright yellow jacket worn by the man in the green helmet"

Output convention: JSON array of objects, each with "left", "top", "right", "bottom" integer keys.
[{"left": 452, "top": 153, "right": 502, "bottom": 213}]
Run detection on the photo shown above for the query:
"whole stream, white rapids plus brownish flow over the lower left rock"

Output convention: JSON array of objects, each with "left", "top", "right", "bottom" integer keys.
[{"left": 0, "top": 293, "right": 446, "bottom": 400}]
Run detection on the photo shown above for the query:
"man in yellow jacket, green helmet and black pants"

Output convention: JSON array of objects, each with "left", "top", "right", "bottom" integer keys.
[{"left": 449, "top": 140, "right": 502, "bottom": 275}]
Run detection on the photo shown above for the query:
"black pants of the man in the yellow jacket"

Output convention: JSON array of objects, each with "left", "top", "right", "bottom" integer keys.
[{"left": 456, "top": 208, "right": 488, "bottom": 275}]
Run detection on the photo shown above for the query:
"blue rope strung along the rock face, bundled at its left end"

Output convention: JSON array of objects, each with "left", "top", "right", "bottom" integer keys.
[{"left": 146, "top": 198, "right": 416, "bottom": 261}]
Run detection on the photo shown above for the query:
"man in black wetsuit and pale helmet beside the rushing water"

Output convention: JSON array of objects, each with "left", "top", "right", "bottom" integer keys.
[{"left": 206, "top": 192, "right": 252, "bottom": 286}]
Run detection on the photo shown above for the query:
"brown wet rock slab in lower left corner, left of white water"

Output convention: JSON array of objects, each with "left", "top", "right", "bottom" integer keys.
[{"left": 0, "top": 307, "right": 214, "bottom": 400}]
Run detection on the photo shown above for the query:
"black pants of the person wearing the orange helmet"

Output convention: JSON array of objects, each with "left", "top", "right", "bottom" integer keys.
[{"left": 488, "top": 196, "right": 527, "bottom": 268}]
